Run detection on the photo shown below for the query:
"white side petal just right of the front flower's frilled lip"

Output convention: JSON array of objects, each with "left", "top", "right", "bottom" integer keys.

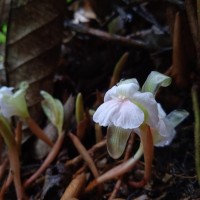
[{"left": 133, "top": 92, "right": 159, "bottom": 128}]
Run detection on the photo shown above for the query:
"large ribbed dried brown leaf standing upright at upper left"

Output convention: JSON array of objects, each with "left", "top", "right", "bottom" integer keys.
[{"left": 5, "top": 0, "right": 62, "bottom": 122}]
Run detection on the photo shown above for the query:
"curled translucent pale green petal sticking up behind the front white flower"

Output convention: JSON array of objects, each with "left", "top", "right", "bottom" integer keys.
[{"left": 142, "top": 71, "right": 171, "bottom": 95}]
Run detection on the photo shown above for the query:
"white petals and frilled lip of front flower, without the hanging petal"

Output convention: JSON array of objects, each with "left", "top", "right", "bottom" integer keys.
[{"left": 93, "top": 79, "right": 159, "bottom": 129}]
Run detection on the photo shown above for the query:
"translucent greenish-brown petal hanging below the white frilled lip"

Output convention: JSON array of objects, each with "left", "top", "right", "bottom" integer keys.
[{"left": 106, "top": 126, "right": 131, "bottom": 159}]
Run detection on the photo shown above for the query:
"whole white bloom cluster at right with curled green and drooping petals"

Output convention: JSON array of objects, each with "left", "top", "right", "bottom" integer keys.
[{"left": 93, "top": 72, "right": 188, "bottom": 158}]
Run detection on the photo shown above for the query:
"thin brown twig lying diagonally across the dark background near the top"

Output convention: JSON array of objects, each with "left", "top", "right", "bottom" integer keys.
[{"left": 67, "top": 22, "right": 147, "bottom": 49}]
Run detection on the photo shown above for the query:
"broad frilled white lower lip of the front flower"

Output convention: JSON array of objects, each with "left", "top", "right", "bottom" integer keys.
[{"left": 93, "top": 100, "right": 144, "bottom": 129}]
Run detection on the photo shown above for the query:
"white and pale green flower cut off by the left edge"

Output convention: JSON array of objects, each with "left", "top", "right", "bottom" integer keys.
[{"left": 0, "top": 82, "right": 29, "bottom": 118}]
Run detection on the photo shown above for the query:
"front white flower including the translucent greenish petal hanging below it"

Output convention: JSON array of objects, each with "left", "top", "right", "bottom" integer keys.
[{"left": 93, "top": 79, "right": 159, "bottom": 158}]
